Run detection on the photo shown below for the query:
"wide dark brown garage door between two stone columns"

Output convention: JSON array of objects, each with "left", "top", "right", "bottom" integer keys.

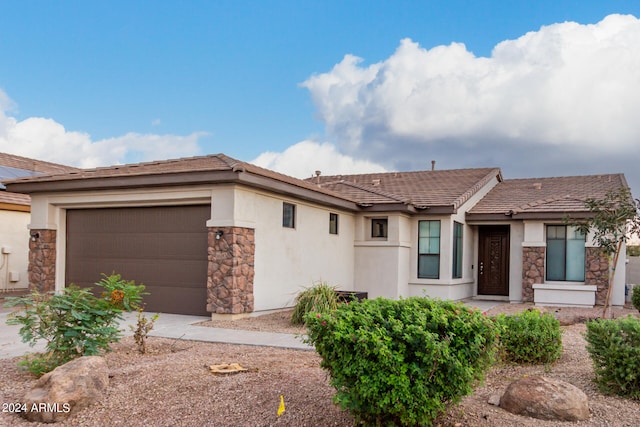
[{"left": 65, "top": 206, "right": 211, "bottom": 315}]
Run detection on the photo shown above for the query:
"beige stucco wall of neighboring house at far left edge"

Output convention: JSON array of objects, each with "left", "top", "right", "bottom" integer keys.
[{"left": 0, "top": 210, "right": 30, "bottom": 292}]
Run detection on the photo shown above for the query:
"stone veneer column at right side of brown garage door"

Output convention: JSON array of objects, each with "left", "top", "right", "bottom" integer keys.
[{"left": 207, "top": 227, "right": 255, "bottom": 314}]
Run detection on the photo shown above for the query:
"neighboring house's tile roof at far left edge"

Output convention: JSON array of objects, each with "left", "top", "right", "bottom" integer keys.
[{"left": 0, "top": 153, "right": 78, "bottom": 211}]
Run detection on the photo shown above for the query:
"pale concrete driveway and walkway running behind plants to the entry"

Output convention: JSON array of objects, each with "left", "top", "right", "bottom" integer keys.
[{"left": 0, "top": 300, "right": 502, "bottom": 359}]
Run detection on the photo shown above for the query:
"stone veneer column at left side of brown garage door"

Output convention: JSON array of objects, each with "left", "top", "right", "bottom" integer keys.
[{"left": 29, "top": 229, "right": 56, "bottom": 293}]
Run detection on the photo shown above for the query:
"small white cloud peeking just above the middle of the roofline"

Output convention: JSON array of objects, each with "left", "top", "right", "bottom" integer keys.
[{"left": 250, "top": 140, "right": 385, "bottom": 178}]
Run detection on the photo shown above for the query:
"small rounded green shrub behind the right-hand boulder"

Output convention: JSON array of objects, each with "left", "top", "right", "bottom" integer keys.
[{"left": 497, "top": 310, "right": 562, "bottom": 363}]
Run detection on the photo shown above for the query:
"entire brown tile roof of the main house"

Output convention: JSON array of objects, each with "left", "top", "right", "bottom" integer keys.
[{"left": 7, "top": 154, "right": 627, "bottom": 218}]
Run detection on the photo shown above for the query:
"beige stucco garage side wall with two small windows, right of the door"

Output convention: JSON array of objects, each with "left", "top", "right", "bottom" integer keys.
[{"left": 208, "top": 188, "right": 354, "bottom": 311}]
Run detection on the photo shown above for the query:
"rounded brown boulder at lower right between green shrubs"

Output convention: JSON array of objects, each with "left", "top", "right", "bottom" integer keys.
[{"left": 500, "top": 376, "right": 589, "bottom": 421}]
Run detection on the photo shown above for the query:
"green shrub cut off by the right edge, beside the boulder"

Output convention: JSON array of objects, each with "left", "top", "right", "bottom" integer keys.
[{"left": 585, "top": 316, "right": 640, "bottom": 399}]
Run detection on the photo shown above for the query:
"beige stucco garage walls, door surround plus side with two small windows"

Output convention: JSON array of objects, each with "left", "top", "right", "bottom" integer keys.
[{"left": 31, "top": 185, "right": 354, "bottom": 311}]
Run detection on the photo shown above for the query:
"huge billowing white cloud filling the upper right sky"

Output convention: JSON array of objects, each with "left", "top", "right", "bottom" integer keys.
[{"left": 302, "top": 15, "right": 640, "bottom": 160}]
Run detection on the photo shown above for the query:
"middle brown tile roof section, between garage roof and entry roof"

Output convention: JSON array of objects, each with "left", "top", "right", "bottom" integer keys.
[{"left": 307, "top": 168, "right": 502, "bottom": 210}]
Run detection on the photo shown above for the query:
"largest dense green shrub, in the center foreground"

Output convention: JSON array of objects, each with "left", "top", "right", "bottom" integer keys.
[{"left": 306, "top": 297, "right": 498, "bottom": 426}]
